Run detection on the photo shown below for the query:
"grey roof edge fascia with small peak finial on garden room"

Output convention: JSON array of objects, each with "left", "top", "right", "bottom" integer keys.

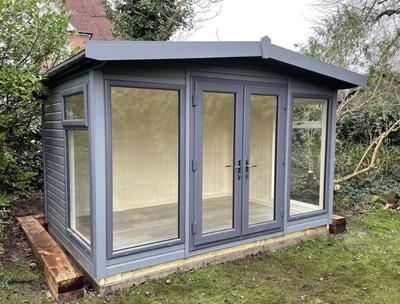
[{"left": 45, "top": 36, "right": 367, "bottom": 87}]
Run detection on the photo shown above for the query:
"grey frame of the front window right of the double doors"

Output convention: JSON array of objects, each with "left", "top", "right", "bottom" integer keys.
[{"left": 287, "top": 93, "right": 333, "bottom": 222}]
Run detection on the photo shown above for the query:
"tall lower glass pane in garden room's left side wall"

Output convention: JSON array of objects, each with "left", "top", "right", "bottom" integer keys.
[{"left": 68, "top": 130, "right": 90, "bottom": 243}]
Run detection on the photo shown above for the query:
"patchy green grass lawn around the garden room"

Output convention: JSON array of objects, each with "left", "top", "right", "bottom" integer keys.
[{"left": 0, "top": 210, "right": 400, "bottom": 304}]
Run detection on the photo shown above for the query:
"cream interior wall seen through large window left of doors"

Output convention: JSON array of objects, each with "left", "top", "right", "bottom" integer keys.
[{"left": 111, "top": 87, "right": 179, "bottom": 211}]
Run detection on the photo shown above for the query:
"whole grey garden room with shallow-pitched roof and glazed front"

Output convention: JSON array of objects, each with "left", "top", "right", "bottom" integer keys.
[{"left": 43, "top": 37, "right": 366, "bottom": 290}]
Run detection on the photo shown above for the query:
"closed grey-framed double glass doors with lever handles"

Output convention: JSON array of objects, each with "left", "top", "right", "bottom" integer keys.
[{"left": 192, "top": 79, "right": 286, "bottom": 246}]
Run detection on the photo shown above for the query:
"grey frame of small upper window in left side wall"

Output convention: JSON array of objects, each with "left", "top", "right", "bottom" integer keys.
[{"left": 61, "top": 83, "right": 89, "bottom": 128}]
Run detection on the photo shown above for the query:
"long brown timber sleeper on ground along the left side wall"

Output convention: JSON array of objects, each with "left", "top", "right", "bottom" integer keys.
[{"left": 17, "top": 216, "right": 84, "bottom": 302}]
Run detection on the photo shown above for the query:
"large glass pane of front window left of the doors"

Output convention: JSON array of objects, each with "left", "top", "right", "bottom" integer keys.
[{"left": 111, "top": 87, "right": 179, "bottom": 250}]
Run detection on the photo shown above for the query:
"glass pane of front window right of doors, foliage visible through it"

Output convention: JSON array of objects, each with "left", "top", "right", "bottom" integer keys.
[{"left": 290, "top": 98, "right": 327, "bottom": 215}]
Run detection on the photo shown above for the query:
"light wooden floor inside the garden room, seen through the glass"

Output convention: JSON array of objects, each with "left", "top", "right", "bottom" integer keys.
[{"left": 76, "top": 197, "right": 315, "bottom": 250}]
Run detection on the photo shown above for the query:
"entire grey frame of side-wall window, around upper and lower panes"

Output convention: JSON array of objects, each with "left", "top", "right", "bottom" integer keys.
[{"left": 61, "top": 83, "right": 94, "bottom": 252}]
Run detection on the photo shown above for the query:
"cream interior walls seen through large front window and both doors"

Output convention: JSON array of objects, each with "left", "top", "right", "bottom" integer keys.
[{"left": 111, "top": 87, "right": 276, "bottom": 211}]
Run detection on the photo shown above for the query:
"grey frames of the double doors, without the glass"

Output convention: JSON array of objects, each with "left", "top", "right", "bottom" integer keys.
[{"left": 189, "top": 76, "right": 288, "bottom": 250}]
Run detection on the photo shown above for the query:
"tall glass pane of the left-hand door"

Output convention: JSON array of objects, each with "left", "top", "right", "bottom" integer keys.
[{"left": 202, "top": 92, "right": 235, "bottom": 233}]
